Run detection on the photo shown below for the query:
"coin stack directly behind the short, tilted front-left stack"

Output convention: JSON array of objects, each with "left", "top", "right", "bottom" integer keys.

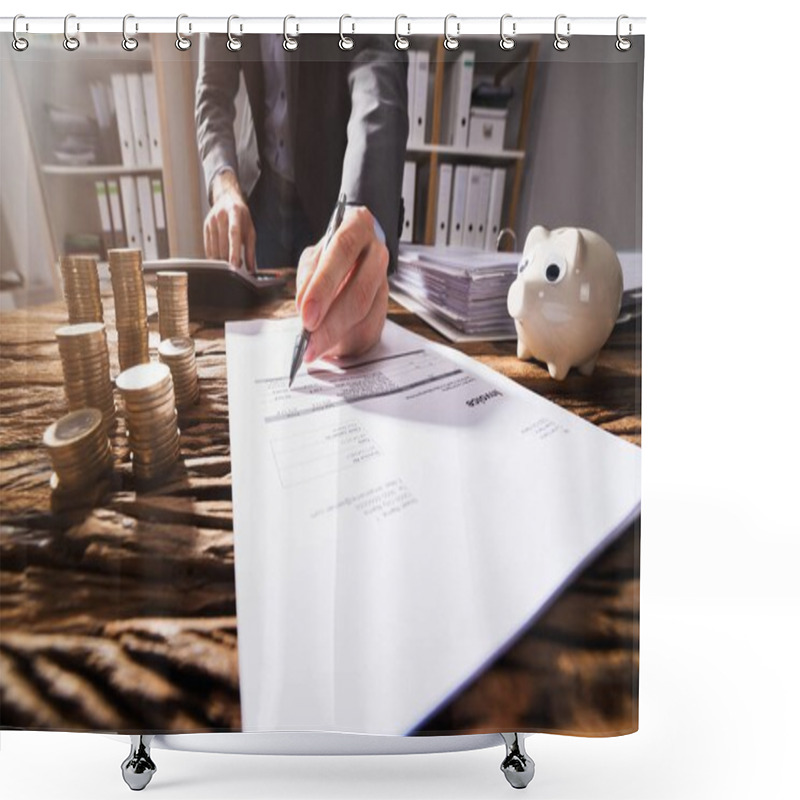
[{"left": 56, "top": 322, "right": 116, "bottom": 430}]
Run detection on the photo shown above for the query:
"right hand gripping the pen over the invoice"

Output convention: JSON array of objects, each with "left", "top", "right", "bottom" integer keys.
[{"left": 295, "top": 206, "right": 389, "bottom": 362}]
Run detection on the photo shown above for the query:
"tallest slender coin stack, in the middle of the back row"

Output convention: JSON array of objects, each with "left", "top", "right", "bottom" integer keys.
[{"left": 108, "top": 249, "right": 150, "bottom": 371}]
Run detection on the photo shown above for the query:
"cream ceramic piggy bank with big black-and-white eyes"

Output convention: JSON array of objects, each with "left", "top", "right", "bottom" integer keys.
[{"left": 508, "top": 225, "right": 622, "bottom": 380}]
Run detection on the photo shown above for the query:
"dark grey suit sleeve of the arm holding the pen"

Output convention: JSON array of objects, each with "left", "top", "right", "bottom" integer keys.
[{"left": 342, "top": 36, "right": 408, "bottom": 272}]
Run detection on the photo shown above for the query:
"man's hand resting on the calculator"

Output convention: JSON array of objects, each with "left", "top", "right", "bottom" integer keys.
[{"left": 203, "top": 170, "right": 256, "bottom": 272}]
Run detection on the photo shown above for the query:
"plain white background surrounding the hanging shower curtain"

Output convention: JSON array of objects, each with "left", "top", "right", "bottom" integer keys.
[{"left": 0, "top": 0, "right": 800, "bottom": 800}]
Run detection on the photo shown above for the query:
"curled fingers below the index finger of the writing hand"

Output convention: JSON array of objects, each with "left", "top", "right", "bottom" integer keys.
[{"left": 305, "top": 240, "right": 389, "bottom": 361}]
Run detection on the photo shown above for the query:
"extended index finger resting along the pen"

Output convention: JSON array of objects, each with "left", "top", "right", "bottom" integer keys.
[{"left": 300, "top": 207, "right": 376, "bottom": 331}]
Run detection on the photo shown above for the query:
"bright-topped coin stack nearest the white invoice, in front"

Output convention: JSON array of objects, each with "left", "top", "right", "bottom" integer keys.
[{"left": 117, "top": 361, "right": 181, "bottom": 481}]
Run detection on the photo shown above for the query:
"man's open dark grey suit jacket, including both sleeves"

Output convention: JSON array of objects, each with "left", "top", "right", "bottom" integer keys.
[{"left": 195, "top": 34, "right": 408, "bottom": 269}]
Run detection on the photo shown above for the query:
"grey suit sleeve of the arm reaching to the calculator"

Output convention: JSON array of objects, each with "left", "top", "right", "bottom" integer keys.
[{"left": 194, "top": 33, "right": 240, "bottom": 201}]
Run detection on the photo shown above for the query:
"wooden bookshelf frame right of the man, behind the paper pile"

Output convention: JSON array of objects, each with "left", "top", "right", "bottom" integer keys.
[{"left": 406, "top": 36, "right": 539, "bottom": 244}]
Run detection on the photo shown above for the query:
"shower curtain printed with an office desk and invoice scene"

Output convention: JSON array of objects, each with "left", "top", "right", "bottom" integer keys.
[{"left": 0, "top": 27, "right": 644, "bottom": 736}]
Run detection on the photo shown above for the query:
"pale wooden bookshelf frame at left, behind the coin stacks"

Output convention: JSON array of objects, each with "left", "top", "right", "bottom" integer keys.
[{"left": 3, "top": 33, "right": 204, "bottom": 296}]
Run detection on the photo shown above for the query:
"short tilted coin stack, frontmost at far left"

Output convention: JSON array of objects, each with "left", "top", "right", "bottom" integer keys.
[{"left": 44, "top": 408, "right": 114, "bottom": 493}]
